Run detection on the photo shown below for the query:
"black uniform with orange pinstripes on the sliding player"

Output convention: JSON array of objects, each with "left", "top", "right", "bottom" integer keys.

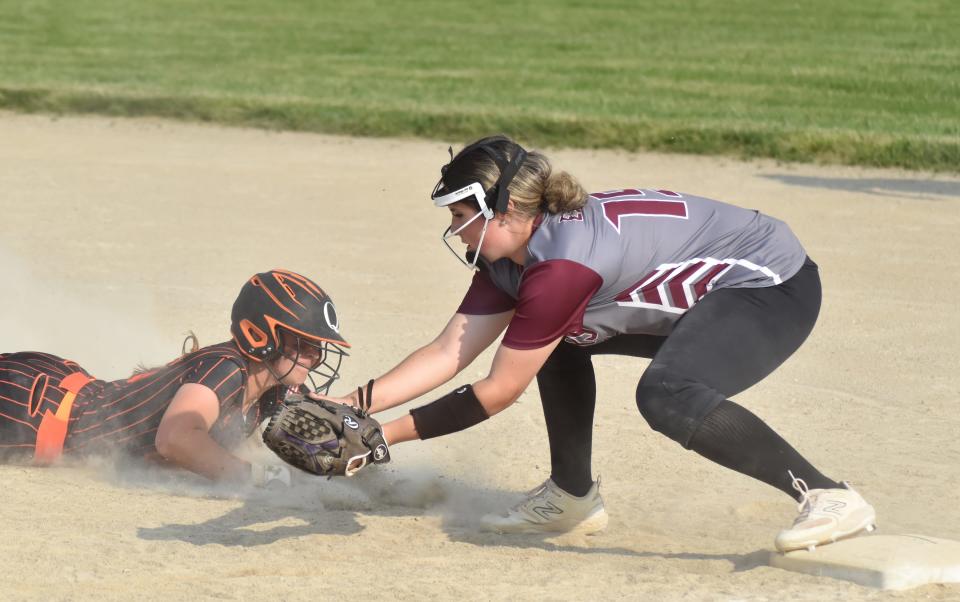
[{"left": 0, "top": 341, "right": 286, "bottom": 455}]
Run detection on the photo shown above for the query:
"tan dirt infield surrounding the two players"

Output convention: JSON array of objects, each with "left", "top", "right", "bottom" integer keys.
[{"left": 0, "top": 113, "right": 960, "bottom": 600}]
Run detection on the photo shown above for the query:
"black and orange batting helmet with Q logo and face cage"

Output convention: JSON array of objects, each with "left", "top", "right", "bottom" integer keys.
[{"left": 230, "top": 269, "right": 350, "bottom": 391}]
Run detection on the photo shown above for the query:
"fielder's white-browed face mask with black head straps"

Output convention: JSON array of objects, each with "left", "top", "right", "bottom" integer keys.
[{"left": 430, "top": 136, "right": 527, "bottom": 270}]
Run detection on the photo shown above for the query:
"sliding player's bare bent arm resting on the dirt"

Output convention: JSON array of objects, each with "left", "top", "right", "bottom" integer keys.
[{"left": 155, "top": 383, "right": 251, "bottom": 482}]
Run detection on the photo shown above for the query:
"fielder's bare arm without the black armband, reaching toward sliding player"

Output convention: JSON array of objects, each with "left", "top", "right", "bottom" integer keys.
[{"left": 330, "top": 311, "right": 513, "bottom": 413}]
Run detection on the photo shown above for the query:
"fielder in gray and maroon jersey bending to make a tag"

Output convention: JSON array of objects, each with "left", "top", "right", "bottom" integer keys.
[{"left": 338, "top": 136, "right": 876, "bottom": 551}]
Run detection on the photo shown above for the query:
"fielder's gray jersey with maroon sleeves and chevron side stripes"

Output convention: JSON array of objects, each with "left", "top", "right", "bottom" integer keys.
[{"left": 458, "top": 188, "right": 806, "bottom": 349}]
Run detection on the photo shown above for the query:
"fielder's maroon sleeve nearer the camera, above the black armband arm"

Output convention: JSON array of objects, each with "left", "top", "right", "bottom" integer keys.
[{"left": 503, "top": 259, "right": 603, "bottom": 349}]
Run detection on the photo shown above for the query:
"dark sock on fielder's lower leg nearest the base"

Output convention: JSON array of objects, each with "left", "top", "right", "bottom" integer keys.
[{"left": 690, "top": 400, "right": 842, "bottom": 499}]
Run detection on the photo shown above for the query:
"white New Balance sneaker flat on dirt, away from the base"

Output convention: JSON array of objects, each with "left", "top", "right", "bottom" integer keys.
[{"left": 480, "top": 479, "right": 607, "bottom": 535}]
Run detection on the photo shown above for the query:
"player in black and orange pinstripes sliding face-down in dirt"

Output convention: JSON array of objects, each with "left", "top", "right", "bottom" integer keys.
[{"left": 0, "top": 270, "right": 349, "bottom": 485}]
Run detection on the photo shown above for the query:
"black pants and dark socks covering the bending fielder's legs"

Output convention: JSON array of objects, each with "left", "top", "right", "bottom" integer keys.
[{"left": 537, "top": 259, "right": 836, "bottom": 495}]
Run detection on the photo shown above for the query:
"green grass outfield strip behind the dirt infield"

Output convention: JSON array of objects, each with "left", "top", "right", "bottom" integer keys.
[{"left": 0, "top": 0, "right": 960, "bottom": 171}]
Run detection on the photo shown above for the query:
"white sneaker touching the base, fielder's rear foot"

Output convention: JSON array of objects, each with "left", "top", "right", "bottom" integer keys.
[{"left": 774, "top": 472, "right": 877, "bottom": 552}]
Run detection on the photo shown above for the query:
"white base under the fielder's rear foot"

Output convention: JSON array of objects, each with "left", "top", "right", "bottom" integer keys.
[{"left": 770, "top": 535, "right": 960, "bottom": 589}]
